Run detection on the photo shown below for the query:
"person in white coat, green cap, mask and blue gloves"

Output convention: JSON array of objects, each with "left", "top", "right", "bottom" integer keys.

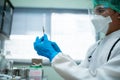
[{"left": 34, "top": 0, "right": 120, "bottom": 80}]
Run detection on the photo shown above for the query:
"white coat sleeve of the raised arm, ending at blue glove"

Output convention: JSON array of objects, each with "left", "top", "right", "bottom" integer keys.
[{"left": 52, "top": 52, "right": 120, "bottom": 80}]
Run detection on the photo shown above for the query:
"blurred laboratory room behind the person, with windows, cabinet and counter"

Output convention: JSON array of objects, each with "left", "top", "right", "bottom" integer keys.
[{"left": 0, "top": 0, "right": 98, "bottom": 80}]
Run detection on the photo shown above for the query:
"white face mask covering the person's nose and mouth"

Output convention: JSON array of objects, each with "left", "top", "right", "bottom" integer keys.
[{"left": 92, "top": 15, "right": 112, "bottom": 34}]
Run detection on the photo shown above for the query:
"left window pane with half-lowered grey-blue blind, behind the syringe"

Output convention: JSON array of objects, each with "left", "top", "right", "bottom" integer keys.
[{"left": 5, "top": 9, "right": 50, "bottom": 59}]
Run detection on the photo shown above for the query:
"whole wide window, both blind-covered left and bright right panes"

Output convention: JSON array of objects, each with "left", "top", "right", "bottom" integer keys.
[{"left": 5, "top": 9, "right": 95, "bottom": 60}]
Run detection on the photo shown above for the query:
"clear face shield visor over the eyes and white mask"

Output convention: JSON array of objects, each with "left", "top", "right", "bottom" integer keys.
[{"left": 89, "top": 5, "right": 112, "bottom": 36}]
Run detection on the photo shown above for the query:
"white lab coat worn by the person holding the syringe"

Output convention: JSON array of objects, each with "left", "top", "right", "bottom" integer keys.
[{"left": 52, "top": 30, "right": 120, "bottom": 80}]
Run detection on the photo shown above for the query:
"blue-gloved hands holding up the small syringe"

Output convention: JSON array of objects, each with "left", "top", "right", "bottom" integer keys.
[{"left": 34, "top": 34, "right": 61, "bottom": 61}]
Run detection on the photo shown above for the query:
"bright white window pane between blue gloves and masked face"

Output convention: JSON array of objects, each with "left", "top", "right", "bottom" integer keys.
[{"left": 51, "top": 13, "right": 95, "bottom": 60}]
